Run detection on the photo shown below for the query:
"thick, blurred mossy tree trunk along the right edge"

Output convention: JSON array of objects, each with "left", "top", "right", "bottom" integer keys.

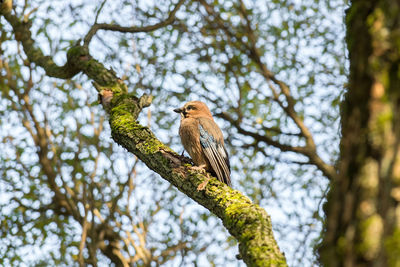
[{"left": 319, "top": 0, "right": 400, "bottom": 266}]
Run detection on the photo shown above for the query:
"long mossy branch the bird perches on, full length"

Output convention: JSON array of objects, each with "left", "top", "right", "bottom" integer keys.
[{"left": 0, "top": 7, "right": 287, "bottom": 266}]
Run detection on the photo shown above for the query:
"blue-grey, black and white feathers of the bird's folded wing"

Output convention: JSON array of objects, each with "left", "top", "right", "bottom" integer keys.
[{"left": 199, "top": 124, "right": 231, "bottom": 186}]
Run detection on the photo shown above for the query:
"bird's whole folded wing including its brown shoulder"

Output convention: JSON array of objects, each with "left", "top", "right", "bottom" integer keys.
[{"left": 199, "top": 119, "right": 231, "bottom": 186}]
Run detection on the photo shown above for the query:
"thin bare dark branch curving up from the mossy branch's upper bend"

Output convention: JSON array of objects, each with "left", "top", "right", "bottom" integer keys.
[{"left": 83, "top": 0, "right": 186, "bottom": 46}]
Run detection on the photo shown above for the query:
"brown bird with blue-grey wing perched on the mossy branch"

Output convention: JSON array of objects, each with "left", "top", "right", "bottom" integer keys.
[{"left": 174, "top": 101, "right": 231, "bottom": 188}]
